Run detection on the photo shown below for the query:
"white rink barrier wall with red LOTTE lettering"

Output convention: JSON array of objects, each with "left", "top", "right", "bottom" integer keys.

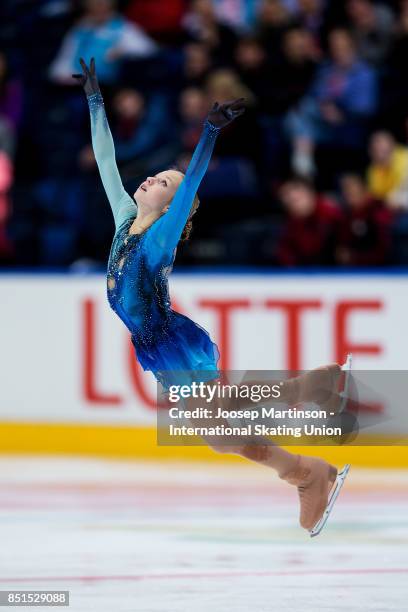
[{"left": 0, "top": 274, "right": 408, "bottom": 425}]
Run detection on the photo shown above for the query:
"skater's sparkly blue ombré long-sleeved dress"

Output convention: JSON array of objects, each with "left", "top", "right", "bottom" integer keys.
[{"left": 88, "top": 94, "right": 219, "bottom": 389}]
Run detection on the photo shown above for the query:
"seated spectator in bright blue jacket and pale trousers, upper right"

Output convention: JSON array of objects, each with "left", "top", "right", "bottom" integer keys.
[{"left": 287, "top": 29, "right": 377, "bottom": 176}]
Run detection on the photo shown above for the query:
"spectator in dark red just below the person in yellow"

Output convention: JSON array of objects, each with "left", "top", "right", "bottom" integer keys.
[{"left": 336, "top": 174, "right": 392, "bottom": 266}]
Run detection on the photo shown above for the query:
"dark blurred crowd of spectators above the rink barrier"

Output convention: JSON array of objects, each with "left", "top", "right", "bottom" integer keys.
[{"left": 0, "top": 0, "right": 408, "bottom": 270}]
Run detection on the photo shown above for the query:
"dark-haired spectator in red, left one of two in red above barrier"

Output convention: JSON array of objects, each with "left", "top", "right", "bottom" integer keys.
[{"left": 277, "top": 178, "right": 342, "bottom": 266}]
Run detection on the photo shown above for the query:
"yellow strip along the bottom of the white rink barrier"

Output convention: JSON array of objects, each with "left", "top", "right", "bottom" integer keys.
[{"left": 0, "top": 423, "right": 408, "bottom": 468}]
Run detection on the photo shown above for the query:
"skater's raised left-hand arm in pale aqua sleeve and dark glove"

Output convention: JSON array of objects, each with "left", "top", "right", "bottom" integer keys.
[{"left": 73, "top": 58, "right": 137, "bottom": 229}]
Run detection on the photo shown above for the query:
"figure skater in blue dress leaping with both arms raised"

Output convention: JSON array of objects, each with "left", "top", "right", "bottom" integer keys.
[{"left": 73, "top": 58, "right": 348, "bottom": 535}]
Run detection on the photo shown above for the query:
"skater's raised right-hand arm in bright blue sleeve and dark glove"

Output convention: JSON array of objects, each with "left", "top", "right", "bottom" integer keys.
[{"left": 146, "top": 99, "right": 245, "bottom": 261}]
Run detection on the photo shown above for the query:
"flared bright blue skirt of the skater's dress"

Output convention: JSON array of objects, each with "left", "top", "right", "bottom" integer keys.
[{"left": 132, "top": 313, "right": 220, "bottom": 390}]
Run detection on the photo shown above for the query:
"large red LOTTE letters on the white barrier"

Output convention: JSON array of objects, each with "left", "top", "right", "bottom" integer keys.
[{"left": 80, "top": 298, "right": 384, "bottom": 409}]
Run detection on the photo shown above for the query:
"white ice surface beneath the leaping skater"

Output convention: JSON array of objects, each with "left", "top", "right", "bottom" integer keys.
[{"left": 0, "top": 456, "right": 408, "bottom": 612}]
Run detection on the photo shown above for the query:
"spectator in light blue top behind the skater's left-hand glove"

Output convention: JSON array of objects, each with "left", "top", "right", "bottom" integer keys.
[{"left": 49, "top": 0, "right": 156, "bottom": 85}]
